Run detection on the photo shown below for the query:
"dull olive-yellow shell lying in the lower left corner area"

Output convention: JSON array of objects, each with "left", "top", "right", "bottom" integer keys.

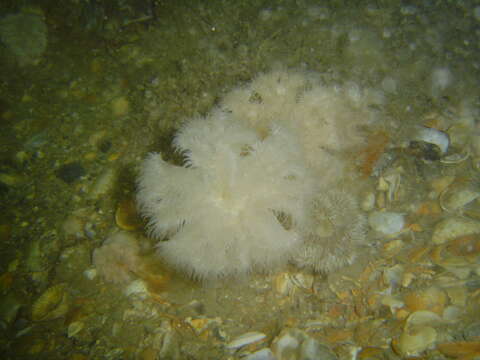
[{"left": 32, "top": 284, "right": 69, "bottom": 321}]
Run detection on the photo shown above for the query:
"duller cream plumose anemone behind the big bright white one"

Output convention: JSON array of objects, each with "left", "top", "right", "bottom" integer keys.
[{"left": 221, "top": 70, "right": 381, "bottom": 184}]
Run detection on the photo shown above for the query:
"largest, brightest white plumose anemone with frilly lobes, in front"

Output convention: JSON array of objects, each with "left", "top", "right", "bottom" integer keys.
[{"left": 137, "top": 109, "right": 312, "bottom": 280}]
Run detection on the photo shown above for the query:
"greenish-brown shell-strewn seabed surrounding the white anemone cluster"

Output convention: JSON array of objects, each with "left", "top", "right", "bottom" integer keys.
[{"left": 0, "top": 0, "right": 480, "bottom": 360}]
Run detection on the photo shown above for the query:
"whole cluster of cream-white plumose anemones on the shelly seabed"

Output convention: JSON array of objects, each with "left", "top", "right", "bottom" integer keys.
[{"left": 137, "top": 70, "right": 379, "bottom": 280}]
